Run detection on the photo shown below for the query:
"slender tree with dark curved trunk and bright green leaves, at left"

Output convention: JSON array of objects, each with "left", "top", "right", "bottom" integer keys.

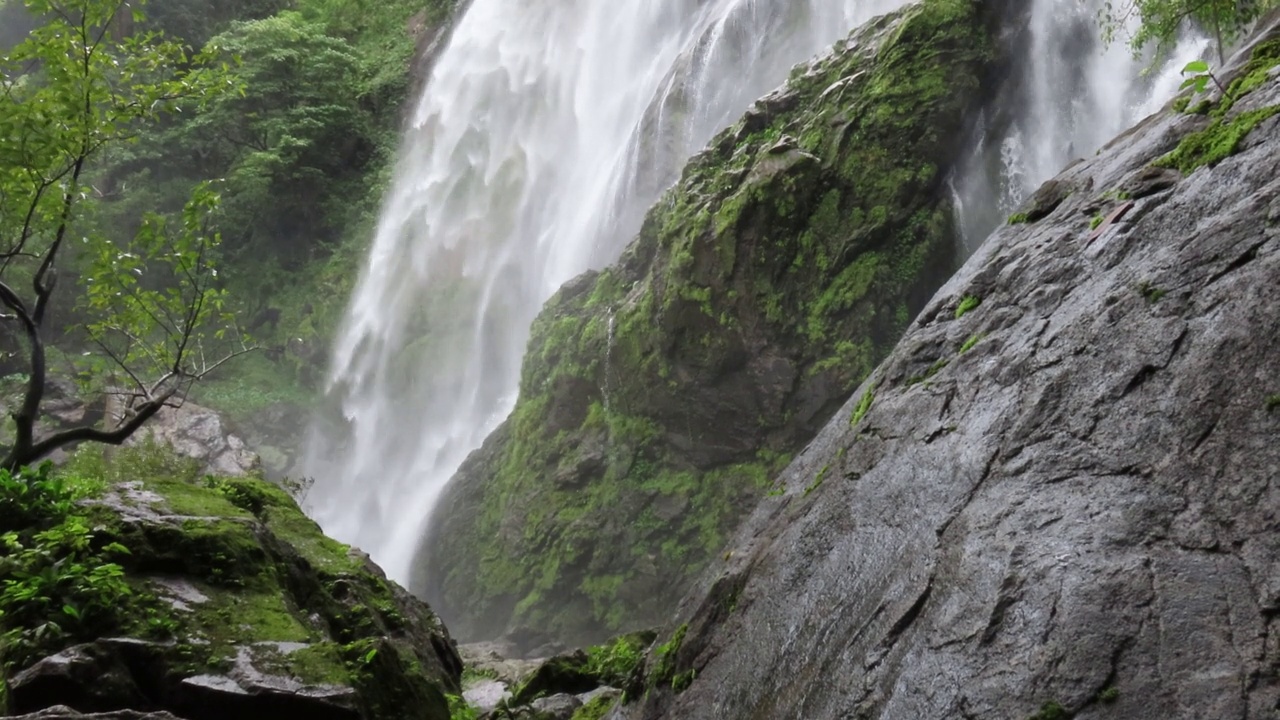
[{"left": 0, "top": 0, "right": 251, "bottom": 470}]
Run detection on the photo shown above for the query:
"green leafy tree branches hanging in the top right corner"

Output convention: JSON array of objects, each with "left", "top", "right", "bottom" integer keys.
[{"left": 1102, "top": 0, "right": 1280, "bottom": 64}]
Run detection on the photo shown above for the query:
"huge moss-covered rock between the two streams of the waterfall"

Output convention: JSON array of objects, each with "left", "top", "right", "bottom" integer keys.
[{"left": 413, "top": 0, "right": 998, "bottom": 644}]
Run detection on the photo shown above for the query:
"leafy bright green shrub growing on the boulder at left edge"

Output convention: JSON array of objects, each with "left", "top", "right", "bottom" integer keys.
[{"left": 0, "top": 464, "right": 132, "bottom": 670}]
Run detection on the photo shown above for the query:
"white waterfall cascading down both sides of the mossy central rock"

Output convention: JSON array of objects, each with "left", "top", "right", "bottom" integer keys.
[{"left": 305, "top": 0, "right": 1203, "bottom": 579}]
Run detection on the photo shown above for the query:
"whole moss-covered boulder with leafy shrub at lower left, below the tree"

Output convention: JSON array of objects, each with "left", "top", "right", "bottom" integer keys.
[{"left": 0, "top": 447, "right": 462, "bottom": 720}]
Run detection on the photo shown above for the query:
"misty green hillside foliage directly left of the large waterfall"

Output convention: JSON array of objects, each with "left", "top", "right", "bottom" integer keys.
[{"left": 95, "top": 0, "right": 456, "bottom": 394}]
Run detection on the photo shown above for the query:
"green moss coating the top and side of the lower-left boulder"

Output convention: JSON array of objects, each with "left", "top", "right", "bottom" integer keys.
[{"left": 10, "top": 447, "right": 452, "bottom": 720}]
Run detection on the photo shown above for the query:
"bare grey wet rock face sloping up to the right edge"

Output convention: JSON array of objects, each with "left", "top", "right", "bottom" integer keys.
[{"left": 630, "top": 19, "right": 1280, "bottom": 720}]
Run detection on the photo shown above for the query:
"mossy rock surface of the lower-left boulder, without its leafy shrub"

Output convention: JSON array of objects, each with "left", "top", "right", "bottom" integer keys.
[{"left": 5, "top": 448, "right": 462, "bottom": 720}]
